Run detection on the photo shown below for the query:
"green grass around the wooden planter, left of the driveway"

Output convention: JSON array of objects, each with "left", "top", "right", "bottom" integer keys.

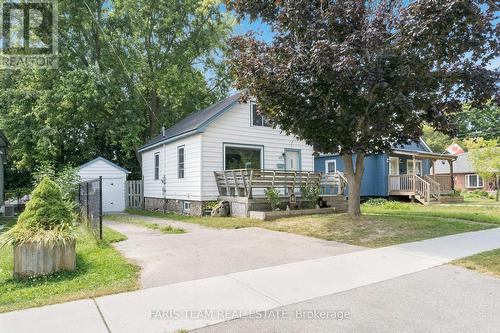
[{"left": 0, "top": 219, "right": 139, "bottom": 312}]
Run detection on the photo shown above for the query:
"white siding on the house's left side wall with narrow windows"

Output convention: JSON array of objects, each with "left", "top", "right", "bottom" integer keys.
[{"left": 142, "top": 134, "right": 201, "bottom": 201}]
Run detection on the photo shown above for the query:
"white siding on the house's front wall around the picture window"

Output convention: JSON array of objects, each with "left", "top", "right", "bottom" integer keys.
[{"left": 202, "top": 103, "right": 314, "bottom": 200}]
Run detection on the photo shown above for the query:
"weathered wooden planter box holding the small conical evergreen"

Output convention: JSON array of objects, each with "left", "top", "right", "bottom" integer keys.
[{"left": 14, "top": 240, "right": 76, "bottom": 278}]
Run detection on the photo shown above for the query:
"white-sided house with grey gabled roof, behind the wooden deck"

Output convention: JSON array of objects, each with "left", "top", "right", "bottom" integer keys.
[{"left": 139, "top": 94, "right": 314, "bottom": 215}]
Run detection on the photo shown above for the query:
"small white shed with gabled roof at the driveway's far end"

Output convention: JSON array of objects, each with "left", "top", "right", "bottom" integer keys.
[{"left": 78, "top": 157, "right": 130, "bottom": 213}]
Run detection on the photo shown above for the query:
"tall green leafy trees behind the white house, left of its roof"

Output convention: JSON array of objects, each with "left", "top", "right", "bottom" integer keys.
[{"left": 0, "top": 0, "right": 233, "bottom": 186}]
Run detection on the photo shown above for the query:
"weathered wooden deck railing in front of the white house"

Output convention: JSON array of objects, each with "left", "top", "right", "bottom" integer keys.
[{"left": 214, "top": 169, "right": 345, "bottom": 198}]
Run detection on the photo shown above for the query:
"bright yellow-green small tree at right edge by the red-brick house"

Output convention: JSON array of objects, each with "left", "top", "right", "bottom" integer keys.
[{"left": 466, "top": 138, "right": 500, "bottom": 201}]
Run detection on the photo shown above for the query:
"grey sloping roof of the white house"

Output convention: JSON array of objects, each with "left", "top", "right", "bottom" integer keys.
[{"left": 139, "top": 93, "right": 241, "bottom": 152}]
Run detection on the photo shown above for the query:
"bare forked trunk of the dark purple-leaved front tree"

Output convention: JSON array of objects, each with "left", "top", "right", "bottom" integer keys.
[{"left": 342, "top": 153, "right": 365, "bottom": 216}]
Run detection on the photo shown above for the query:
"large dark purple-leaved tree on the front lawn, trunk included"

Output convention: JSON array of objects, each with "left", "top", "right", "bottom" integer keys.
[{"left": 228, "top": 0, "right": 499, "bottom": 215}]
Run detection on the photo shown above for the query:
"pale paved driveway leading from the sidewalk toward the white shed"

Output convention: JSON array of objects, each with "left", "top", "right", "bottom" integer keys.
[{"left": 106, "top": 217, "right": 363, "bottom": 288}]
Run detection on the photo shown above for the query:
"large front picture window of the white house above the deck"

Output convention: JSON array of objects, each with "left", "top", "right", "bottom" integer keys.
[{"left": 224, "top": 145, "right": 263, "bottom": 170}]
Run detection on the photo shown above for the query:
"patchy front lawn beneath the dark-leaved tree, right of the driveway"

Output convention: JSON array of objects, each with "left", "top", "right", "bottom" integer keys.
[{"left": 123, "top": 203, "right": 500, "bottom": 247}]
